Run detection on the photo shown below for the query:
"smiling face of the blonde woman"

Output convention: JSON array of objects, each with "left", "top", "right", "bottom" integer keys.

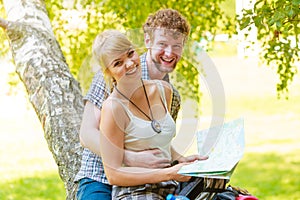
[{"left": 108, "top": 48, "right": 141, "bottom": 82}]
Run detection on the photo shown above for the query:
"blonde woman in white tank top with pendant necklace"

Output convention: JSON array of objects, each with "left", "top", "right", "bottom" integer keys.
[{"left": 93, "top": 30, "right": 206, "bottom": 199}]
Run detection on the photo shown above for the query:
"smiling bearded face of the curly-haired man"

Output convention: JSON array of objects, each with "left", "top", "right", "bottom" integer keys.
[{"left": 149, "top": 29, "right": 184, "bottom": 73}]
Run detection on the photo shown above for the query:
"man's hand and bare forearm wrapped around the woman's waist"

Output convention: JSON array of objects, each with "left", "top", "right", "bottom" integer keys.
[{"left": 124, "top": 149, "right": 171, "bottom": 168}]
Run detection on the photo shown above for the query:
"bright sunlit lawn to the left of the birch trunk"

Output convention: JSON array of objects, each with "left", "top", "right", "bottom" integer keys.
[{"left": 0, "top": 90, "right": 66, "bottom": 200}]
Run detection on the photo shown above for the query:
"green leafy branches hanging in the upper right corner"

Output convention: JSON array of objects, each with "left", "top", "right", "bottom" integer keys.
[{"left": 239, "top": 0, "right": 300, "bottom": 97}]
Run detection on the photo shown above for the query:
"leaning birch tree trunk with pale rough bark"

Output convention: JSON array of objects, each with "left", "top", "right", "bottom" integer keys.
[{"left": 0, "top": 0, "right": 83, "bottom": 199}]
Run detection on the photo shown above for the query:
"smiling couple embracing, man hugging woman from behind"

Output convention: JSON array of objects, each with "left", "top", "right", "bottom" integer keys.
[{"left": 75, "top": 9, "right": 213, "bottom": 200}]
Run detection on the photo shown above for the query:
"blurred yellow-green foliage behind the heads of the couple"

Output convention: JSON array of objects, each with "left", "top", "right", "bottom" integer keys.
[{"left": 46, "top": 0, "right": 234, "bottom": 101}]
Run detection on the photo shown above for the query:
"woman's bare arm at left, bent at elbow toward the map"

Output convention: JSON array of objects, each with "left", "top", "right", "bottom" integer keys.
[{"left": 100, "top": 101, "right": 190, "bottom": 186}]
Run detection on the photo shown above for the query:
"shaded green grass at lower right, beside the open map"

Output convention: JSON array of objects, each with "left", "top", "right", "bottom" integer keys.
[{"left": 231, "top": 152, "right": 300, "bottom": 200}]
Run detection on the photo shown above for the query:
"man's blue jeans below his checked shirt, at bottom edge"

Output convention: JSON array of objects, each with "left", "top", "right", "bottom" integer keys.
[{"left": 76, "top": 178, "right": 112, "bottom": 200}]
